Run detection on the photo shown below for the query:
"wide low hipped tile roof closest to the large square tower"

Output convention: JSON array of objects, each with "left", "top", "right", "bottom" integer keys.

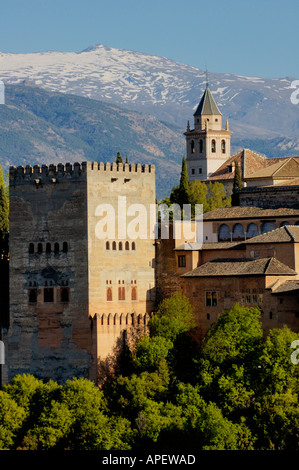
[{"left": 182, "top": 258, "right": 297, "bottom": 277}]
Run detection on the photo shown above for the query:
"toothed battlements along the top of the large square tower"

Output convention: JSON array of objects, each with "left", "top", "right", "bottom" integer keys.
[{"left": 9, "top": 162, "right": 155, "bottom": 184}]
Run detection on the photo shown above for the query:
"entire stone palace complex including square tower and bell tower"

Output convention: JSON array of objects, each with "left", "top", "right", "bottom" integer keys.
[{"left": 4, "top": 86, "right": 299, "bottom": 383}]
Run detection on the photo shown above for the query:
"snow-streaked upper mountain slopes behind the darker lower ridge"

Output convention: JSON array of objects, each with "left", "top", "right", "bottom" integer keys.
[{"left": 0, "top": 45, "right": 299, "bottom": 139}]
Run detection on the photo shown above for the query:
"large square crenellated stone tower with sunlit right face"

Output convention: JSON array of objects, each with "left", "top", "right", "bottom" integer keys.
[{"left": 6, "top": 162, "right": 155, "bottom": 381}]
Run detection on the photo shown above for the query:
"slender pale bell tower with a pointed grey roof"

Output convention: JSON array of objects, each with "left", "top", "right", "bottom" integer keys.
[{"left": 185, "top": 85, "right": 232, "bottom": 181}]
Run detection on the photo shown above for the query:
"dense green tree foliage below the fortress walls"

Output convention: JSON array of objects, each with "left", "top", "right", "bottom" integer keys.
[{"left": 0, "top": 293, "right": 299, "bottom": 452}]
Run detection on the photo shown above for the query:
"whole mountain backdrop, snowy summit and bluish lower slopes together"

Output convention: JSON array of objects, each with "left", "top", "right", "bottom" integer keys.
[{"left": 0, "top": 44, "right": 299, "bottom": 196}]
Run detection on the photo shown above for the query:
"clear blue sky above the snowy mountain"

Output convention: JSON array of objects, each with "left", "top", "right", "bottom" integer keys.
[{"left": 0, "top": 0, "right": 299, "bottom": 79}]
